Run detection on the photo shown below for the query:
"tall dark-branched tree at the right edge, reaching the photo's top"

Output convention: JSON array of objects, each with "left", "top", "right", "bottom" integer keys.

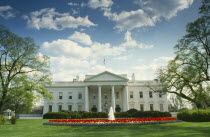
[{"left": 158, "top": 0, "right": 210, "bottom": 108}]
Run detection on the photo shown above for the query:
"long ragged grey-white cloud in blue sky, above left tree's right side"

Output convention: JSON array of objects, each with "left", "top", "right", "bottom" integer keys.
[{"left": 23, "top": 8, "right": 96, "bottom": 30}]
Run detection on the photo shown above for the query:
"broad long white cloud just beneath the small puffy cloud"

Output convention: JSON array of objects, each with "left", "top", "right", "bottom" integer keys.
[{"left": 42, "top": 39, "right": 125, "bottom": 59}]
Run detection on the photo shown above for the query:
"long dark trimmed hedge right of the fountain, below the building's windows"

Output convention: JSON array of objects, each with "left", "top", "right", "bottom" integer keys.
[{"left": 115, "top": 110, "right": 171, "bottom": 118}]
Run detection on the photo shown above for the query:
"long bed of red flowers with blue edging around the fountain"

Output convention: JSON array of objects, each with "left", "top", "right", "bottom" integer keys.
[{"left": 43, "top": 117, "right": 181, "bottom": 126}]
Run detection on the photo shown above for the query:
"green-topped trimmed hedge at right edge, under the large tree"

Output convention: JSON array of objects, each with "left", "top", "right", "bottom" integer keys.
[{"left": 177, "top": 109, "right": 210, "bottom": 122}]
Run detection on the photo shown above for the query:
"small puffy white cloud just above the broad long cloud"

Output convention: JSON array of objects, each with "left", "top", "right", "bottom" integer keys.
[{"left": 68, "top": 31, "right": 92, "bottom": 45}]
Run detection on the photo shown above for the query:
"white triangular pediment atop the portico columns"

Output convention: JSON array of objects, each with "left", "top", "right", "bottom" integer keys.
[{"left": 85, "top": 71, "right": 128, "bottom": 81}]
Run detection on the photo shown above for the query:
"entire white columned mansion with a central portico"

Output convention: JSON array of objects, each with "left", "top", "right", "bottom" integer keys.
[{"left": 44, "top": 71, "right": 168, "bottom": 113}]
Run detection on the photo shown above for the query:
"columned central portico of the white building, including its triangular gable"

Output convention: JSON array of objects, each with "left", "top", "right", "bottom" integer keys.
[{"left": 84, "top": 71, "right": 129, "bottom": 112}]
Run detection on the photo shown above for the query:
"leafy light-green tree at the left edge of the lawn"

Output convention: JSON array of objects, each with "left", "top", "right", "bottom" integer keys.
[{"left": 0, "top": 26, "right": 51, "bottom": 112}]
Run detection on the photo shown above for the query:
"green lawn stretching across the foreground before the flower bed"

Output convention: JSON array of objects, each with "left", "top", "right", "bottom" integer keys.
[{"left": 0, "top": 119, "right": 210, "bottom": 137}]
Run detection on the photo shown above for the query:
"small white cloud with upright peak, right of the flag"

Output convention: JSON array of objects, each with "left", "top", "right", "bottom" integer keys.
[{"left": 121, "top": 31, "right": 154, "bottom": 49}]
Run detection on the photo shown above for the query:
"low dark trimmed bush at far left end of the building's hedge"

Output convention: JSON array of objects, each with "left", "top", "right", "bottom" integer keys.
[{"left": 43, "top": 112, "right": 70, "bottom": 119}]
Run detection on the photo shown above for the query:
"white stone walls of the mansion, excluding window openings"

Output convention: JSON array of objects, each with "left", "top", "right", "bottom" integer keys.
[{"left": 44, "top": 72, "right": 168, "bottom": 113}]
